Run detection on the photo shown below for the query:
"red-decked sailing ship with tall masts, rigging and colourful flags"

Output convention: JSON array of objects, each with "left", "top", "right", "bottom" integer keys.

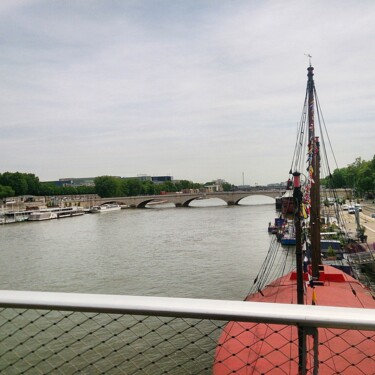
[{"left": 213, "top": 62, "right": 375, "bottom": 375}]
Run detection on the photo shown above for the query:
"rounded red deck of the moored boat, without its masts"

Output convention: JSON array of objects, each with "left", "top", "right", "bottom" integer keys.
[{"left": 213, "top": 266, "right": 375, "bottom": 375}]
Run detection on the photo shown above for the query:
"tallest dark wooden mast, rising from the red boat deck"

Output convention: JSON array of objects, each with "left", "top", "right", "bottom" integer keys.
[{"left": 307, "top": 65, "right": 321, "bottom": 278}]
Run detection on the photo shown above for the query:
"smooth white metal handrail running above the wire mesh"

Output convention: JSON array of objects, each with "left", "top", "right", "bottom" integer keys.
[{"left": 0, "top": 290, "right": 375, "bottom": 330}]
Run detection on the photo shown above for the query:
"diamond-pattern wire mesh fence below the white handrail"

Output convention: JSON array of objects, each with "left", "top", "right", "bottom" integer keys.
[{"left": 0, "top": 300, "right": 375, "bottom": 375}]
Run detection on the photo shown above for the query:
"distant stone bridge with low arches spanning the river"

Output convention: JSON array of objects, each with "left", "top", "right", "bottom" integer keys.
[{"left": 88, "top": 190, "right": 282, "bottom": 208}]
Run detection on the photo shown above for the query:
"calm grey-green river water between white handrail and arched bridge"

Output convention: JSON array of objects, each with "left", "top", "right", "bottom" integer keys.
[{"left": 0, "top": 197, "right": 275, "bottom": 300}]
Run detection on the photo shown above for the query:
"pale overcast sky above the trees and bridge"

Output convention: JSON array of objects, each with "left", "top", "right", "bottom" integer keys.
[{"left": 0, "top": 0, "right": 375, "bottom": 185}]
